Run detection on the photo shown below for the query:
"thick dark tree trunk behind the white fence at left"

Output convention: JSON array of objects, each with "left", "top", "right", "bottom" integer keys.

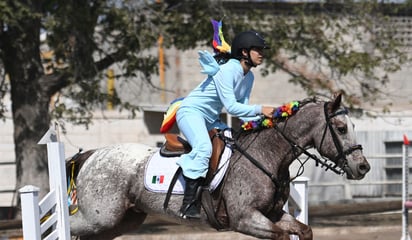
[{"left": 1, "top": 7, "right": 52, "bottom": 208}]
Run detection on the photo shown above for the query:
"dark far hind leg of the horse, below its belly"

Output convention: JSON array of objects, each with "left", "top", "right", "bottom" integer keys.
[{"left": 80, "top": 209, "right": 147, "bottom": 240}]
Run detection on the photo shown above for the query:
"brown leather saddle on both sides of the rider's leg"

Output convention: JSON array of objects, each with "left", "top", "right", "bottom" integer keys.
[{"left": 160, "top": 129, "right": 225, "bottom": 183}]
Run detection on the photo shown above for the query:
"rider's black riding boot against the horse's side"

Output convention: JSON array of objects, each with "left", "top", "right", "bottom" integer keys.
[{"left": 180, "top": 176, "right": 203, "bottom": 219}]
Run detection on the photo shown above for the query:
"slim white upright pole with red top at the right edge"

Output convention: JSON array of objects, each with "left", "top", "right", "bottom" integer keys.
[{"left": 401, "top": 135, "right": 412, "bottom": 240}]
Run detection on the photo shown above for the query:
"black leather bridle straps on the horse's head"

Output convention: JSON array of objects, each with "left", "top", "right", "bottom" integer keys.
[{"left": 319, "top": 103, "right": 362, "bottom": 174}]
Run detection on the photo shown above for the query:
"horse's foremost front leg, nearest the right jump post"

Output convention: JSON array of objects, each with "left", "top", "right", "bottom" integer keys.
[{"left": 271, "top": 211, "right": 313, "bottom": 240}]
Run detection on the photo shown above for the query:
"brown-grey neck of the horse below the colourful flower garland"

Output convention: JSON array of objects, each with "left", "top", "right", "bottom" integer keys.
[{"left": 232, "top": 104, "right": 324, "bottom": 177}]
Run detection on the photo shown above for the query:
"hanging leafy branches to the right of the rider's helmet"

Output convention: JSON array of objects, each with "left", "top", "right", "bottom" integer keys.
[{"left": 248, "top": 1, "right": 408, "bottom": 107}]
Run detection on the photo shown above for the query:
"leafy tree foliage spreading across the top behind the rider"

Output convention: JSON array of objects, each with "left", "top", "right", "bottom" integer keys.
[{"left": 0, "top": 0, "right": 408, "bottom": 124}]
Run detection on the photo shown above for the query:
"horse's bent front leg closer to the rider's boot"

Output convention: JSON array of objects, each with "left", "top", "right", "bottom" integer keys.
[{"left": 230, "top": 208, "right": 290, "bottom": 240}]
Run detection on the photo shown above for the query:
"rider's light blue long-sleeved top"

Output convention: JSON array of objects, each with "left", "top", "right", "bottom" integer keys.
[{"left": 179, "top": 59, "right": 262, "bottom": 124}]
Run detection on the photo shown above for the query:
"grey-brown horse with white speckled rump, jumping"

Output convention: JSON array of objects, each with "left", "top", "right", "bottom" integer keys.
[{"left": 70, "top": 95, "right": 370, "bottom": 240}]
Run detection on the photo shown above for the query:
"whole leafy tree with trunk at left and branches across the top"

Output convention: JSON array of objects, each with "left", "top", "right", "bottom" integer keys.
[{"left": 0, "top": 0, "right": 408, "bottom": 210}]
